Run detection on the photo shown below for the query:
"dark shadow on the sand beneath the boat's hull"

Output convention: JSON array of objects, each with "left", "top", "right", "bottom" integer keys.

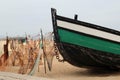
[{"left": 70, "top": 69, "right": 120, "bottom": 77}]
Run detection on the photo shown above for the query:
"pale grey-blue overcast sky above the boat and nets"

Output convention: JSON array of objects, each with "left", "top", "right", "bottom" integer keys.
[{"left": 0, "top": 0, "right": 120, "bottom": 36}]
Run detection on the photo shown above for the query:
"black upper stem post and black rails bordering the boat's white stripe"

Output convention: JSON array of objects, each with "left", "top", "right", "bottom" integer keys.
[{"left": 51, "top": 8, "right": 120, "bottom": 44}]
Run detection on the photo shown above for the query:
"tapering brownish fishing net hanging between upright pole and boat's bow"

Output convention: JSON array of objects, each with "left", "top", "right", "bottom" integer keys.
[{"left": 43, "top": 32, "right": 54, "bottom": 71}]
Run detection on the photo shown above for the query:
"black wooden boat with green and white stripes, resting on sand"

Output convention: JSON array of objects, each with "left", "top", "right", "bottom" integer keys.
[{"left": 51, "top": 9, "right": 120, "bottom": 68}]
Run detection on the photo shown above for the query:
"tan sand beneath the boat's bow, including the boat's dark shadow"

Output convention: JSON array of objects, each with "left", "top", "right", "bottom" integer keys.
[{"left": 35, "top": 59, "right": 120, "bottom": 80}]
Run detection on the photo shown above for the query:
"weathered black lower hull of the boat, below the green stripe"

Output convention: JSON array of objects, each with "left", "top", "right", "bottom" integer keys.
[{"left": 59, "top": 43, "right": 120, "bottom": 68}]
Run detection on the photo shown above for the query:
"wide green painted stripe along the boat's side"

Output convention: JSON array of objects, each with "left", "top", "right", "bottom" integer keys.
[{"left": 58, "top": 29, "right": 120, "bottom": 54}]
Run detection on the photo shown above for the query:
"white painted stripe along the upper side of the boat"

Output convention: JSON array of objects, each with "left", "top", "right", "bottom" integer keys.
[{"left": 57, "top": 20, "right": 120, "bottom": 42}]
